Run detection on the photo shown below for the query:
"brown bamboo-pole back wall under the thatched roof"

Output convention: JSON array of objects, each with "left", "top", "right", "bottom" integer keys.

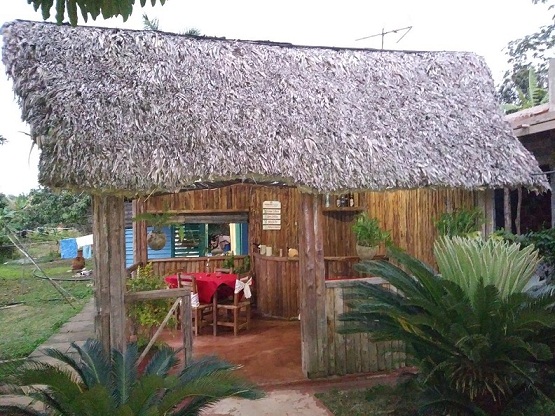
[{"left": 137, "top": 184, "right": 478, "bottom": 264}]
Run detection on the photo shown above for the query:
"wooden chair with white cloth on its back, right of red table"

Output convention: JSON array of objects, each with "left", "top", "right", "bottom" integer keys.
[{"left": 214, "top": 276, "right": 252, "bottom": 336}]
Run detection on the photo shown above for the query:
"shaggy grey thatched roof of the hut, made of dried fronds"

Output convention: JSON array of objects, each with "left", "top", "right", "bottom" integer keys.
[{"left": 3, "top": 21, "right": 547, "bottom": 193}]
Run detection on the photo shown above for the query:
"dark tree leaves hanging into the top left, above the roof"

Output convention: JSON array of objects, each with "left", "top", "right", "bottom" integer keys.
[{"left": 27, "top": 0, "right": 166, "bottom": 26}]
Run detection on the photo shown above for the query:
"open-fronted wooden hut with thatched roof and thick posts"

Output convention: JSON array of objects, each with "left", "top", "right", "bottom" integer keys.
[{"left": 2, "top": 21, "right": 549, "bottom": 377}]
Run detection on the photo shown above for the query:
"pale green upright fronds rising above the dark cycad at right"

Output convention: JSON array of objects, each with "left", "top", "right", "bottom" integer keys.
[{"left": 434, "top": 237, "right": 539, "bottom": 301}]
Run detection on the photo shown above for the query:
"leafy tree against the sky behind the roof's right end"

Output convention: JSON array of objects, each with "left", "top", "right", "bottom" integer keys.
[{"left": 499, "top": 0, "right": 555, "bottom": 105}]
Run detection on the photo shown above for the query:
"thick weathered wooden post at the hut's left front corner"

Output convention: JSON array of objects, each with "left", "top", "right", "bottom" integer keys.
[{"left": 92, "top": 195, "right": 126, "bottom": 351}]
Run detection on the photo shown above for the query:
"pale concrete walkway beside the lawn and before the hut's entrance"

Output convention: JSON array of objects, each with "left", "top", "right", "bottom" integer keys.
[{"left": 29, "top": 300, "right": 332, "bottom": 416}]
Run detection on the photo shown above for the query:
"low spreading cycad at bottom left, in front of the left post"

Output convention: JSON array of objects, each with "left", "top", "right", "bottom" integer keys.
[{"left": 0, "top": 340, "right": 261, "bottom": 416}]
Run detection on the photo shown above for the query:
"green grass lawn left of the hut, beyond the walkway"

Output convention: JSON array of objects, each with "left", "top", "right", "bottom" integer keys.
[{"left": 0, "top": 260, "right": 92, "bottom": 360}]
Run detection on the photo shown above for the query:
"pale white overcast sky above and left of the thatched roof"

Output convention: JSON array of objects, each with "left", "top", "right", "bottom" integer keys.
[{"left": 0, "top": 0, "right": 555, "bottom": 195}]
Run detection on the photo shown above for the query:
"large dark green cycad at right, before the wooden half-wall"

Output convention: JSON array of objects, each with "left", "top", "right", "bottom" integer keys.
[{"left": 341, "top": 242, "right": 555, "bottom": 415}]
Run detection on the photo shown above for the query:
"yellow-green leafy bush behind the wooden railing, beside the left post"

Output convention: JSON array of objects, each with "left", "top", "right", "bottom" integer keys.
[{"left": 127, "top": 263, "right": 176, "bottom": 343}]
